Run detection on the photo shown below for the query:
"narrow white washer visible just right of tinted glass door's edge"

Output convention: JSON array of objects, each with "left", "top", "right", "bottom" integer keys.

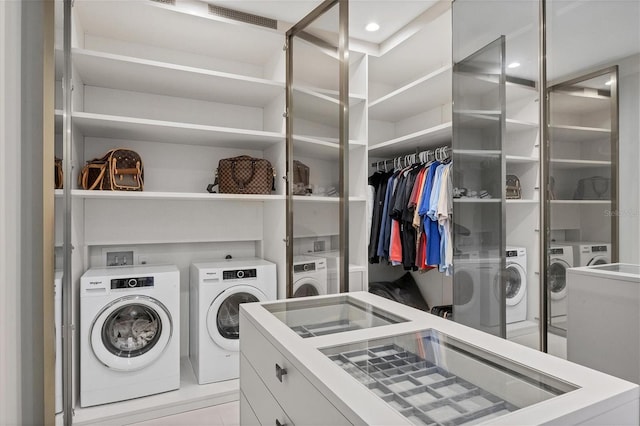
[{"left": 505, "top": 247, "right": 527, "bottom": 324}]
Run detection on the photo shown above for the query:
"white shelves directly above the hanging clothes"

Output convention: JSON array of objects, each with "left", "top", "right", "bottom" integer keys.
[{"left": 368, "top": 4, "right": 451, "bottom": 159}]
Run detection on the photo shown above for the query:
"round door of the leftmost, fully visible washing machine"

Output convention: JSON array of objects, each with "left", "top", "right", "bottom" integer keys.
[{"left": 90, "top": 295, "right": 173, "bottom": 371}]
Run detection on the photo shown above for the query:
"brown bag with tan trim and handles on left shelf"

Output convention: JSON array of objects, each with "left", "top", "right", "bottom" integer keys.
[{"left": 78, "top": 148, "right": 144, "bottom": 191}]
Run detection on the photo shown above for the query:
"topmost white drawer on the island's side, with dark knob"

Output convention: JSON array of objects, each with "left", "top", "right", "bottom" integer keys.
[{"left": 240, "top": 321, "right": 351, "bottom": 425}]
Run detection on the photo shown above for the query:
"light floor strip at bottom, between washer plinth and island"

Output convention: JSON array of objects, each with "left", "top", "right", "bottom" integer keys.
[{"left": 130, "top": 401, "right": 240, "bottom": 426}]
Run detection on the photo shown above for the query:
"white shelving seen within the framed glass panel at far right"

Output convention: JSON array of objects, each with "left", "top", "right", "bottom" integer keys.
[{"left": 547, "top": 67, "right": 618, "bottom": 335}]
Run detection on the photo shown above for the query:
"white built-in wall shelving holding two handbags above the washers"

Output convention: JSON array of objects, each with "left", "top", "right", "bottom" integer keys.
[{"left": 56, "top": 1, "right": 296, "bottom": 424}]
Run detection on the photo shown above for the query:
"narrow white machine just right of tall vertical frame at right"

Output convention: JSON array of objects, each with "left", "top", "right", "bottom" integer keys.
[{"left": 548, "top": 244, "right": 574, "bottom": 323}]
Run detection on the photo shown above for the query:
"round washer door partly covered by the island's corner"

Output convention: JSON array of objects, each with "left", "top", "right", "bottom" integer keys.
[{"left": 207, "top": 285, "right": 268, "bottom": 351}]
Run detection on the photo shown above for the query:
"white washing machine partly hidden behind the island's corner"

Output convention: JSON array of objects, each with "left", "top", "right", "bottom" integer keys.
[{"left": 189, "top": 258, "right": 278, "bottom": 384}]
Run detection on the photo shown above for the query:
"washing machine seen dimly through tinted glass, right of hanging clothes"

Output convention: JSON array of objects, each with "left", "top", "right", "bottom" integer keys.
[{"left": 453, "top": 253, "right": 504, "bottom": 334}]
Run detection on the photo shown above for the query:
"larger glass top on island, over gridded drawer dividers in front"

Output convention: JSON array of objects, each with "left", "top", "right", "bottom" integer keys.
[{"left": 321, "top": 329, "right": 578, "bottom": 425}]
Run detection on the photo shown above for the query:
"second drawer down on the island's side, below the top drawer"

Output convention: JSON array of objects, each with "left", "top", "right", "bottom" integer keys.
[{"left": 240, "top": 355, "right": 292, "bottom": 425}]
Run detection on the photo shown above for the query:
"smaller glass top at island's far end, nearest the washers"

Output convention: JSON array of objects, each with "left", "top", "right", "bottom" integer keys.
[{"left": 264, "top": 295, "right": 407, "bottom": 338}]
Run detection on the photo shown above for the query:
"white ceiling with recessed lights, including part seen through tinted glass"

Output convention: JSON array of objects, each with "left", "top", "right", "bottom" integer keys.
[{"left": 212, "top": 0, "right": 640, "bottom": 80}]
